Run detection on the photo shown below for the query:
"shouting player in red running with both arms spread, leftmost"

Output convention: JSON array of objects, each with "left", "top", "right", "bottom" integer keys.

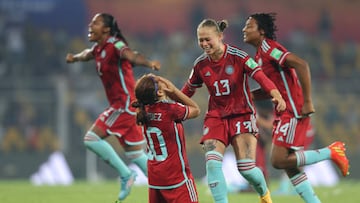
[{"left": 66, "top": 13, "right": 160, "bottom": 200}]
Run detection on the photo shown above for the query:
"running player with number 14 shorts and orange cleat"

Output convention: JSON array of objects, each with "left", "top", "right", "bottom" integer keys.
[{"left": 243, "top": 13, "right": 349, "bottom": 203}]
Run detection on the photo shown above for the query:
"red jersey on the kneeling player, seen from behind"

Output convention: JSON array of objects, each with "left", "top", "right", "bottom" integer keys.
[{"left": 143, "top": 100, "right": 192, "bottom": 189}]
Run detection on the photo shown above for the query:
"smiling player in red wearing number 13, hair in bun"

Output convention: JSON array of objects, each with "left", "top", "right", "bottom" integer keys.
[{"left": 182, "top": 19, "right": 285, "bottom": 203}]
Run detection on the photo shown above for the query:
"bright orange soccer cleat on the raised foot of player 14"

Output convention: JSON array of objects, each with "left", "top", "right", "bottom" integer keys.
[{"left": 328, "top": 141, "right": 350, "bottom": 177}]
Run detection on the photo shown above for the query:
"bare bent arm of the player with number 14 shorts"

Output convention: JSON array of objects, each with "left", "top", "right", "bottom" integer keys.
[{"left": 285, "top": 53, "right": 315, "bottom": 115}]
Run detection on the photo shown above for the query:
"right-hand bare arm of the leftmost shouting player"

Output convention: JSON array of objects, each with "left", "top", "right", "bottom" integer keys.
[{"left": 121, "top": 49, "right": 161, "bottom": 70}]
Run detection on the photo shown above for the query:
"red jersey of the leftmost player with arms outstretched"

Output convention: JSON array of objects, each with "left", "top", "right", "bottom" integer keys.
[{"left": 92, "top": 37, "right": 135, "bottom": 110}]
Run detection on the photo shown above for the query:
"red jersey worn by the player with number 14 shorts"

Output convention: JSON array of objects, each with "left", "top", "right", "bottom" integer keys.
[{"left": 255, "top": 39, "right": 304, "bottom": 118}]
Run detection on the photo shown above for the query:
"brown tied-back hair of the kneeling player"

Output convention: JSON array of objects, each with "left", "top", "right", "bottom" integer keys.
[{"left": 132, "top": 74, "right": 158, "bottom": 125}]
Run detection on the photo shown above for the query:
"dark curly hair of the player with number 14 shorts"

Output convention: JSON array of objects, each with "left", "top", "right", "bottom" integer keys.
[{"left": 249, "top": 13, "right": 277, "bottom": 40}]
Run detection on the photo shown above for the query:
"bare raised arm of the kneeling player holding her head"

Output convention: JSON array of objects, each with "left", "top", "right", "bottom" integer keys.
[{"left": 156, "top": 76, "right": 200, "bottom": 119}]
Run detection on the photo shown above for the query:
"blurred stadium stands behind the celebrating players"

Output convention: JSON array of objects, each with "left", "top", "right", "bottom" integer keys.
[{"left": 0, "top": 0, "right": 360, "bottom": 180}]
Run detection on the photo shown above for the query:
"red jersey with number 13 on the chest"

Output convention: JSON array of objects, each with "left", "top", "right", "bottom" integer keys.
[{"left": 183, "top": 44, "right": 261, "bottom": 117}]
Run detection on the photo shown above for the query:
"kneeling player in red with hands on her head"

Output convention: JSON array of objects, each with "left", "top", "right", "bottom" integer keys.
[{"left": 133, "top": 74, "right": 200, "bottom": 203}]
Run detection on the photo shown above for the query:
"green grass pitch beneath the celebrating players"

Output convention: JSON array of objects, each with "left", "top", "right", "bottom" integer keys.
[{"left": 0, "top": 180, "right": 360, "bottom": 203}]
